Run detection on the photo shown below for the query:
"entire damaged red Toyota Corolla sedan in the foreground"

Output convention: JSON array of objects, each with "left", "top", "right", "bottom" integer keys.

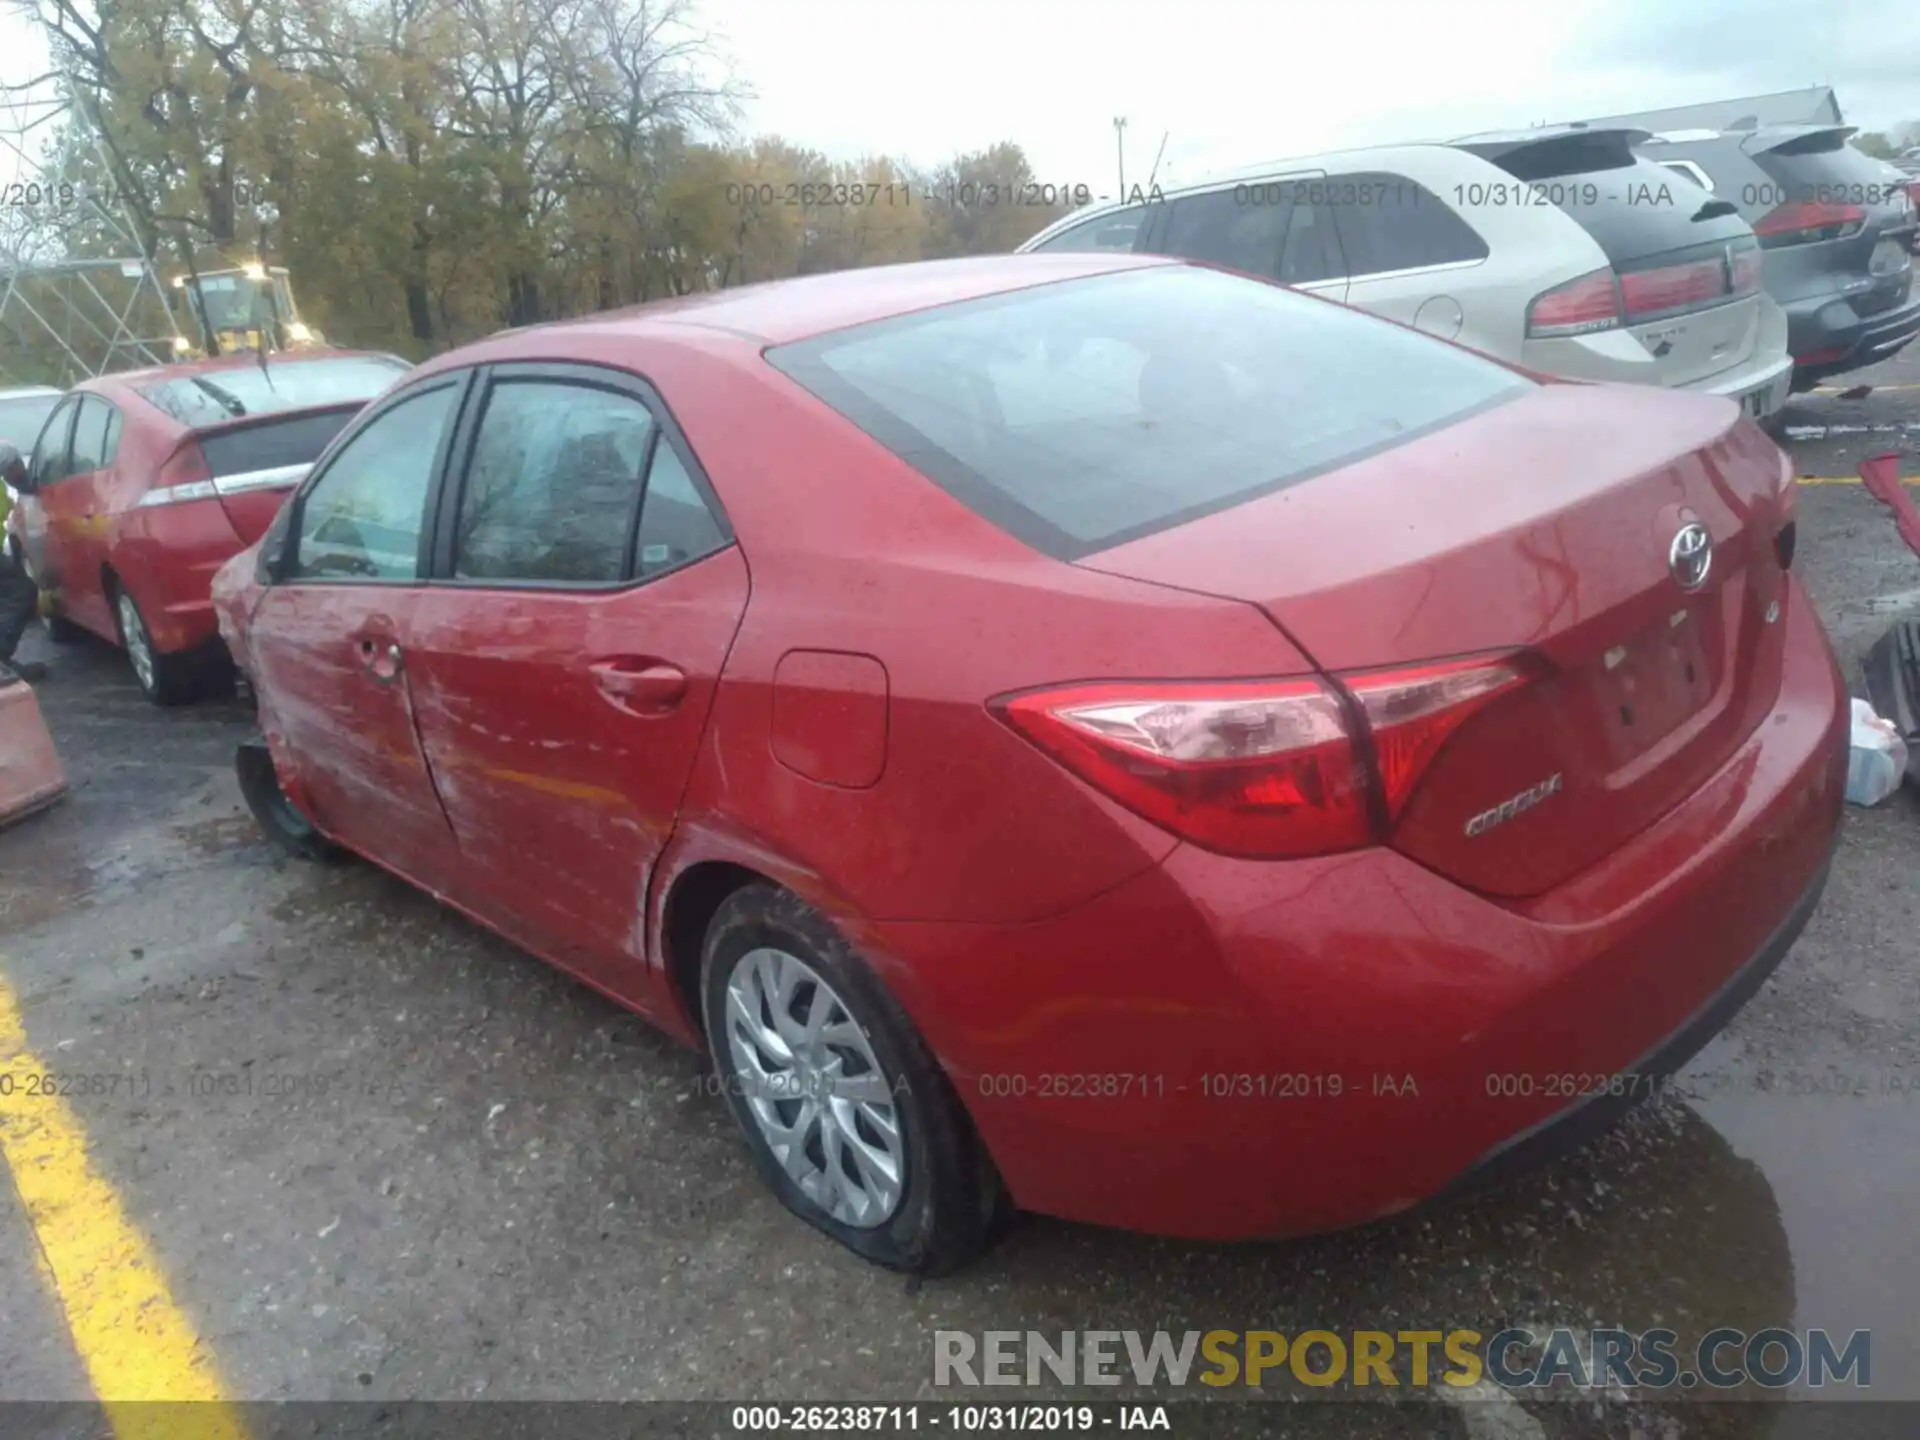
[{"left": 217, "top": 255, "right": 1845, "bottom": 1271}]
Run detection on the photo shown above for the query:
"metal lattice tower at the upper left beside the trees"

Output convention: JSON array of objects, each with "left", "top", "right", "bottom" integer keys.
[{"left": 0, "top": 45, "right": 188, "bottom": 384}]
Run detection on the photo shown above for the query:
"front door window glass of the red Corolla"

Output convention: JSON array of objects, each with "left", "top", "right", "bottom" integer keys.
[{"left": 286, "top": 384, "right": 459, "bottom": 580}]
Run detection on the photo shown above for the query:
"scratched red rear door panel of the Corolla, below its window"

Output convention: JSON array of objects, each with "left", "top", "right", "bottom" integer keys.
[{"left": 405, "top": 547, "right": 749, "bottom": 1010}]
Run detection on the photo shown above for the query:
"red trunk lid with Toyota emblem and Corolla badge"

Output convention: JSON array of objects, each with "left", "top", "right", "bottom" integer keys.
[{"left": 1079, "top": 384, "right": 1789, "bottom": 897}]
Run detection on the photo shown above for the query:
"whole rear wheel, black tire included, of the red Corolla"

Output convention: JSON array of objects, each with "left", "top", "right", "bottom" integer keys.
[{"left": 701, "top": 885, "right": 1008, "bottom": 1275}]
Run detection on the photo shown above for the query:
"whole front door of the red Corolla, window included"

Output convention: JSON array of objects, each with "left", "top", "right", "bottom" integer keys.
[{"left": 248, "top": 374, "right": 467, "bottom": 893}]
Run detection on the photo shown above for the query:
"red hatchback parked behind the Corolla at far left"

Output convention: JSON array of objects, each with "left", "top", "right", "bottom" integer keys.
[{"left": 10, "top": 349, "right": 407, "bottom": 705}]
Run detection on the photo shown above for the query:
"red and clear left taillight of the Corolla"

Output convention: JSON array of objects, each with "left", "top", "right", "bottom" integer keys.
[{"left": 991, "top": 657, "right": 1524, "bottom": 860}]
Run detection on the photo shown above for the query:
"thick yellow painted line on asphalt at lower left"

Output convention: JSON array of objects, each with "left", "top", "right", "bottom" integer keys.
[{"left": 0, "top": 977, "right": 244, "bottom": 1440}]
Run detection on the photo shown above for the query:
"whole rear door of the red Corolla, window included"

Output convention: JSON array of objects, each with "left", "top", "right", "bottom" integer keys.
[{"left": 405, "top": 365, "right": 747, "bottom": 993}]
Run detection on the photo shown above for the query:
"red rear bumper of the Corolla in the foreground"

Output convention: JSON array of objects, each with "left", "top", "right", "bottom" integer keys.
[{"left": 879, "top": 586, "right": 1847, "bottom": 1238}]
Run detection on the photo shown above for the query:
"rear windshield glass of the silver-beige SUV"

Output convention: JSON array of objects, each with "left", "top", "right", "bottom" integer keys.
[{"left": 1466, "top": 136, "right": 1753, "bottom": 269}]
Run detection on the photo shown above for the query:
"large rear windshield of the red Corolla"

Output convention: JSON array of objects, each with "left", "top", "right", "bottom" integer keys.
[{"left": 768, "top": 265, "right": 1534, "bottom": 559}]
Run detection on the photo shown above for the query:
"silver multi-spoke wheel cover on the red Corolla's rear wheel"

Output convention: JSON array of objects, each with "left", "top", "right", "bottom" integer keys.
[{"left": 726, "top": 948, "right": 906, "bottom": 1229}]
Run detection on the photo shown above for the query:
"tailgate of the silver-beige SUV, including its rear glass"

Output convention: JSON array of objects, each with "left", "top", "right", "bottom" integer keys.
[{"left": 1465, "top": 131, "right": 1764, "bottom": 386}]
